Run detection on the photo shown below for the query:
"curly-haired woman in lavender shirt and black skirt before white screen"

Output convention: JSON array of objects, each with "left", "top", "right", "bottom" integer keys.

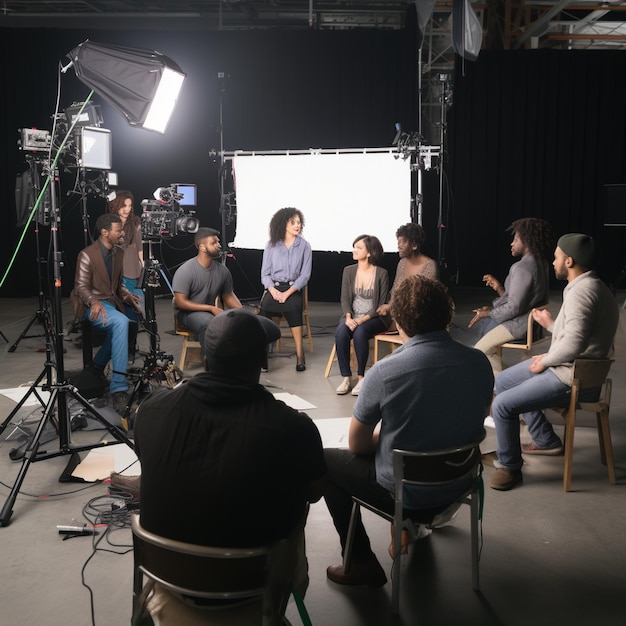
[{"left": 261, "top": 207, "right": 312, "bottom": 372}]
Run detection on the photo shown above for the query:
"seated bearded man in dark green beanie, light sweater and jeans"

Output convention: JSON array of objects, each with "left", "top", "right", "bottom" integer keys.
[{"left": 491, "top": 233, "right": 619, "bottom": 491}]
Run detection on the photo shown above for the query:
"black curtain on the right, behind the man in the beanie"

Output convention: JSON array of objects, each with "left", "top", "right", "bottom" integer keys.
[{"left": 448, "top": 50, "right": 626, "bottom": 285}]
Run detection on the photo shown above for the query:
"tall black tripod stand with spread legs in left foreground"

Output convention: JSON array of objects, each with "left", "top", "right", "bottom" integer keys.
[{"left": 0, "top": 158, "right": 134, "bottom": 526}]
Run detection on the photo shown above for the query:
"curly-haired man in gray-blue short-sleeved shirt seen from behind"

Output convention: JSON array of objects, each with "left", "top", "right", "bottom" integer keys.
[{"left": 324, "top": 275, "right": 493, "bottom": 587}]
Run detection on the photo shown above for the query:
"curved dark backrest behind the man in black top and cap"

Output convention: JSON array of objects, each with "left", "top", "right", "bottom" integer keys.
[{"left": 132, "top": 515, "right": 272, "bottom": 600}]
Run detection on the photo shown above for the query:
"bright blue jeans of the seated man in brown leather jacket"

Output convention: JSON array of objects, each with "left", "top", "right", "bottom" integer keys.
[{"left": 83, "top": 300, "right": 130, "bottom": 393}]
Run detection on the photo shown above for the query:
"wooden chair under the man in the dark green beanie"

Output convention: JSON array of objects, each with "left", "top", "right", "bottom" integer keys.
[{"left": 551, "top": 359, "right": 615, "bottom": 491}]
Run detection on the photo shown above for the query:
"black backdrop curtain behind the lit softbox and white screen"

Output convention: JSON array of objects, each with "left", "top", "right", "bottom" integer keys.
[{"left": 0, "top": 28, "right": 417, "bottom": 300}]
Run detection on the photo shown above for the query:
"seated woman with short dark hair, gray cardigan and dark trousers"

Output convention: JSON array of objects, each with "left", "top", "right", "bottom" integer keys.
[{"left": 335, "top": 235, "right": 389, "bottom": 396}]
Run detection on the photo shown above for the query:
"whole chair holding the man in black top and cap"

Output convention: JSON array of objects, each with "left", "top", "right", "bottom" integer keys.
[{"left": 131, "top": 514, "right": 308, "bottom": 626}]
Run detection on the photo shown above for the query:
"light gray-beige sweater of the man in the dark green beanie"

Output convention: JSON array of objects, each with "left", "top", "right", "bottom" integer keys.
[{"left": 542, "top": 272, "right": 619, "bottom": 385}]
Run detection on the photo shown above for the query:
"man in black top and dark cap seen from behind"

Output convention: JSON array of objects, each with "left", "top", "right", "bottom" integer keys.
[{"left": 135, "top": 308, "right": 326, "bottom": 620}]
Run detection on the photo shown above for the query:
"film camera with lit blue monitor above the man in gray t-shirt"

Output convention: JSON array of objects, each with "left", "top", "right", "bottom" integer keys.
[{"left": 141, "top": 184, "right": 200, "bottom": 240}]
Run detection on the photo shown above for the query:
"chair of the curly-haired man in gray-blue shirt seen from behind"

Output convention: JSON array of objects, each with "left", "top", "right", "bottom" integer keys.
[{"left": 343, "top": 441, "right": 483, "bottom": 615}]
